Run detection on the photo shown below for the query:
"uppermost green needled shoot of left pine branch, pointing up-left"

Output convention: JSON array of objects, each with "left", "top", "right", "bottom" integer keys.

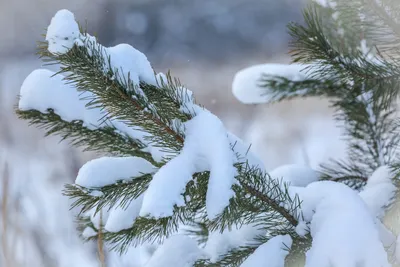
[{"left": 37, "top": 42, "right": 188, "bottom": 152}]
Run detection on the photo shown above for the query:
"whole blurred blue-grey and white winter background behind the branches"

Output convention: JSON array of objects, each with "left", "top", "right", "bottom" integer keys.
[{"left": 0, "top": 0, "right": 343, "bottom": 267}]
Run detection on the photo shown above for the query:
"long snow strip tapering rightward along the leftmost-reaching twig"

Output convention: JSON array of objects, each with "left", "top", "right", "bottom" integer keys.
[{"left": 18, "top": 69, "right": 166, "bottom": 162}]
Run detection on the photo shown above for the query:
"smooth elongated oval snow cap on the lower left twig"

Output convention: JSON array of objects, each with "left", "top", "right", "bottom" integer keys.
[{"left": 75, "top": 157, "right": 156, "bottom": 188}]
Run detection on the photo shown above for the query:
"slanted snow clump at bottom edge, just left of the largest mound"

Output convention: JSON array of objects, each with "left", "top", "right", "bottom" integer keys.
[{"left": 240, "top": 235, "right": 292, "bottom": 267}]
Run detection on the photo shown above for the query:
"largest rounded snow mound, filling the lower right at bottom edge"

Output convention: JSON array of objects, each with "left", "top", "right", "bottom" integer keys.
[{"left": 301, "top": 181, "right": 390, "bottom": 267}]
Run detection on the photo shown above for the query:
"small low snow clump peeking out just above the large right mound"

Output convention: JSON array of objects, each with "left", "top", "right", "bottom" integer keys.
[{"left": 269, "top": 164, "right": 320, "bottom": 187}]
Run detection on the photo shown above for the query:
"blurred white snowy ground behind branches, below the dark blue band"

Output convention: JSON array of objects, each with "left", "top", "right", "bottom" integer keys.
[{"left": 0, "top": 55, "right": 343, "bottom": 267}]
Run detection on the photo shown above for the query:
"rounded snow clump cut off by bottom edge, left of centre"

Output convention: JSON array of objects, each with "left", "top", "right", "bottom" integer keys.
[{"left": 144, "top": 235, "right": 204, "bottom": 267}]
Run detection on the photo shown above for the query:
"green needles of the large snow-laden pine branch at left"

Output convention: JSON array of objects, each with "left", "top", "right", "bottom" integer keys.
[{"left": 19, "top": 19, "right": 306, "bottom": 264}]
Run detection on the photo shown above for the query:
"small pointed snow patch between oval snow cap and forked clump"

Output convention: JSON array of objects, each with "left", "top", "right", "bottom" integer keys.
[{"left": 104, "top": 194, "right": 143, "bottom": 233}]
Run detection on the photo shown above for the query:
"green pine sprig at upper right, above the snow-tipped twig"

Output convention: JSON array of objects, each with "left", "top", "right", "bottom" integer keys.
[{"left": 288, "top": 7, "right": 400, "bottom": 90}]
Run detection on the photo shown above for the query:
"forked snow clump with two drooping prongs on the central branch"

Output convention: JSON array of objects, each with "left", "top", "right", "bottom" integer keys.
[{"left": 140, "top": 111, "right": 236, "bottom": 219}]
